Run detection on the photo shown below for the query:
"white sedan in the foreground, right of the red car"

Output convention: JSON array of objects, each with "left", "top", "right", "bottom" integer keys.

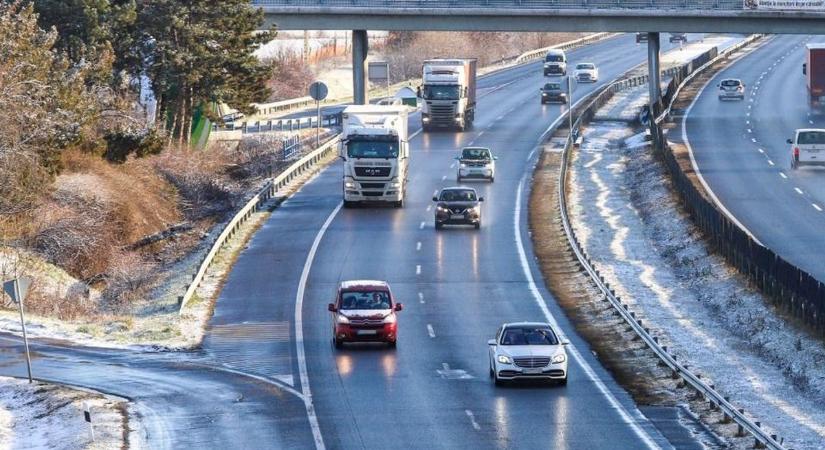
[{"left": 488, "top": 322, "right": 569, "bottom": 386}]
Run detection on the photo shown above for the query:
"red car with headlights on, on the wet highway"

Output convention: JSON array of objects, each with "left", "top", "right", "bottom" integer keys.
[{"left": 328, "top": 280, "right": 404, "bottom": 348}]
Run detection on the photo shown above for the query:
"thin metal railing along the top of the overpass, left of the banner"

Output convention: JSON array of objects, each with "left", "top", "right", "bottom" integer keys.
[{"left": 252, "top": 0, "right": 745, "bottom": 11}]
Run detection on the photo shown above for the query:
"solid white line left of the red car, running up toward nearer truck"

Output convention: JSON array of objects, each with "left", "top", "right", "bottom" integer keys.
[{"left": 295, "top": 202, "right": 344, "bottom": 450}]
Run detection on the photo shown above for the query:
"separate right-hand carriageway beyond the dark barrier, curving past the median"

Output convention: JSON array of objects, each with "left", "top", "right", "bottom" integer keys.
[{"left": 671, "top": 36, "right": 825, "bottom": 280}]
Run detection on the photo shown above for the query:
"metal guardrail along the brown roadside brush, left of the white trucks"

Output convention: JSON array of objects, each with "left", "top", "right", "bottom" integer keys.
[{"left": 178, "top": 137, "right": 339, "bottom": 314}]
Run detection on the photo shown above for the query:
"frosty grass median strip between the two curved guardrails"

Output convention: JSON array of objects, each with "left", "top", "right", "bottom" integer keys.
[{"left": 571, "top": 118, "right": 825, "bottom": 449}]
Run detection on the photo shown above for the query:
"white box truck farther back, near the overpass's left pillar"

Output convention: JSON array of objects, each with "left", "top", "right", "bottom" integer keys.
[{"left": 418, "top": 59, "right": 477, "bottom": 131}]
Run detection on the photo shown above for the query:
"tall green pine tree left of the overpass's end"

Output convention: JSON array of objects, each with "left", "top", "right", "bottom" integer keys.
[{"left": 137, "top": 0, "right": 274, "bottom": 144}]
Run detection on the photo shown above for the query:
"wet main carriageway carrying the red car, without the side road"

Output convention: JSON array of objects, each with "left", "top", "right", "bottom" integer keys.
[{"left": 204, "top": 36, "right": 696, "bottom": 448}]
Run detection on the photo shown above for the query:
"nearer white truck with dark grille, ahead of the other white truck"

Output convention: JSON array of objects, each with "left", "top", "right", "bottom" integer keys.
[{"left": 341, "top": 105, "right": 409, "bottom": 208}]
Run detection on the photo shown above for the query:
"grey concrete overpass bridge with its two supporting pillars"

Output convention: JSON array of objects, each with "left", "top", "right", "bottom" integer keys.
[{"left": 252, "top": 0, "right": 825, "bottom": 135}]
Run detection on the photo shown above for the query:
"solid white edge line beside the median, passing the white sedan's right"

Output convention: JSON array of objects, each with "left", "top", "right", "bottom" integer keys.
[{"left": 513, "top": 178, "right": 659, "bottom": 449}]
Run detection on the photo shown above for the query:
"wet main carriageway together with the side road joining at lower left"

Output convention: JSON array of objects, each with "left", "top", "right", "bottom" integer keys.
[{"left": 0, "top": 35, "right": 698, "bottom": 449}]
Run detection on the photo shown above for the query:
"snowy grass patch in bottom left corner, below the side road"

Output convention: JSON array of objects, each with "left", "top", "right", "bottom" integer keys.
[{"left": 0, "top": 377, "right": 129, "bottom": 450}]
